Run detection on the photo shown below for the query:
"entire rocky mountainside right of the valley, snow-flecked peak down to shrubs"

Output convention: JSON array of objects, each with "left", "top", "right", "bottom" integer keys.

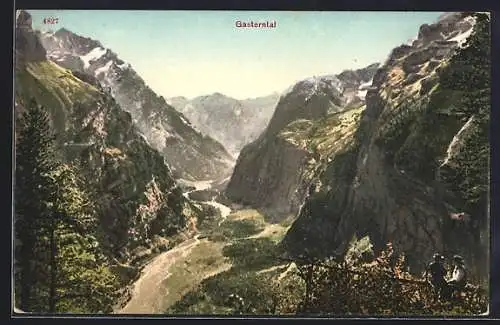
[{"left": 227, "top": 13, "right": 490, "bottom": 274}]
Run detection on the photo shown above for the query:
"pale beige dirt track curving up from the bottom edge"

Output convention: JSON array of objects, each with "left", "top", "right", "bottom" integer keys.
[{"left": 116, "top": 236, "right": 200, "bottom": 314}]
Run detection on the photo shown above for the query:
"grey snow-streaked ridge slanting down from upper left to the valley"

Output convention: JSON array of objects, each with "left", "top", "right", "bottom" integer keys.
[{"left": 40, "top": 29, "right": 233, "bottom": 180}]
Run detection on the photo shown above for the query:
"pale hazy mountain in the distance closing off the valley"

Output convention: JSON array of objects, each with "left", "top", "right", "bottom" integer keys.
[{"left": 168, "top": 93, "right": 278, "bottom": 156}]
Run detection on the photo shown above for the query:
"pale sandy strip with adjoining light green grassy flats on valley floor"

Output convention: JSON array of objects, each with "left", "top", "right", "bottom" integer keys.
[{"left": 115, "top": 210, "right": 288, "bottom": 314}]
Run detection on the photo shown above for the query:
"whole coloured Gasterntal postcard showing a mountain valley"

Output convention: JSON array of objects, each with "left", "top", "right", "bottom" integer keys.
[{"left": 12, "top": 10, "right": 491, "bottom": 317}]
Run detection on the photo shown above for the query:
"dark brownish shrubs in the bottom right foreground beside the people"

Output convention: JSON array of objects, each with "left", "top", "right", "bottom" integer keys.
[{"left": 292, "top": 240, "right": 487, "bottom": 316}]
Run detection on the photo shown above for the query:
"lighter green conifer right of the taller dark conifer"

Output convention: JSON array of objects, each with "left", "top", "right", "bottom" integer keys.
[{"left": 46, "top": 164, "right": 118, "bottom": 312}]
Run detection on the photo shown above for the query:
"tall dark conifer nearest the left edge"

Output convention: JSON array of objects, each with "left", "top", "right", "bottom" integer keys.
[{"left": 14, "top": 99, "right": 55, "bottom": 310}]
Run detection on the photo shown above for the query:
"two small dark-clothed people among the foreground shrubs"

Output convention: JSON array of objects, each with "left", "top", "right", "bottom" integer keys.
[{"left": 425, "top": 253, "right": 467, "bottom": 300}]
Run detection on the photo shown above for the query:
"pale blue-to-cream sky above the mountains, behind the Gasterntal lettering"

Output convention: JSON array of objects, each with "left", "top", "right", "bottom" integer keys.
[{"left": 28, "top": 10, "right": 441, "bottom": 99}]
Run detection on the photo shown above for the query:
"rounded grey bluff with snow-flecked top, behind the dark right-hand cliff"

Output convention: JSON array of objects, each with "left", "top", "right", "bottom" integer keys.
[{"left": 226, "top": 64, "right": 378, "bottom": 219}]
